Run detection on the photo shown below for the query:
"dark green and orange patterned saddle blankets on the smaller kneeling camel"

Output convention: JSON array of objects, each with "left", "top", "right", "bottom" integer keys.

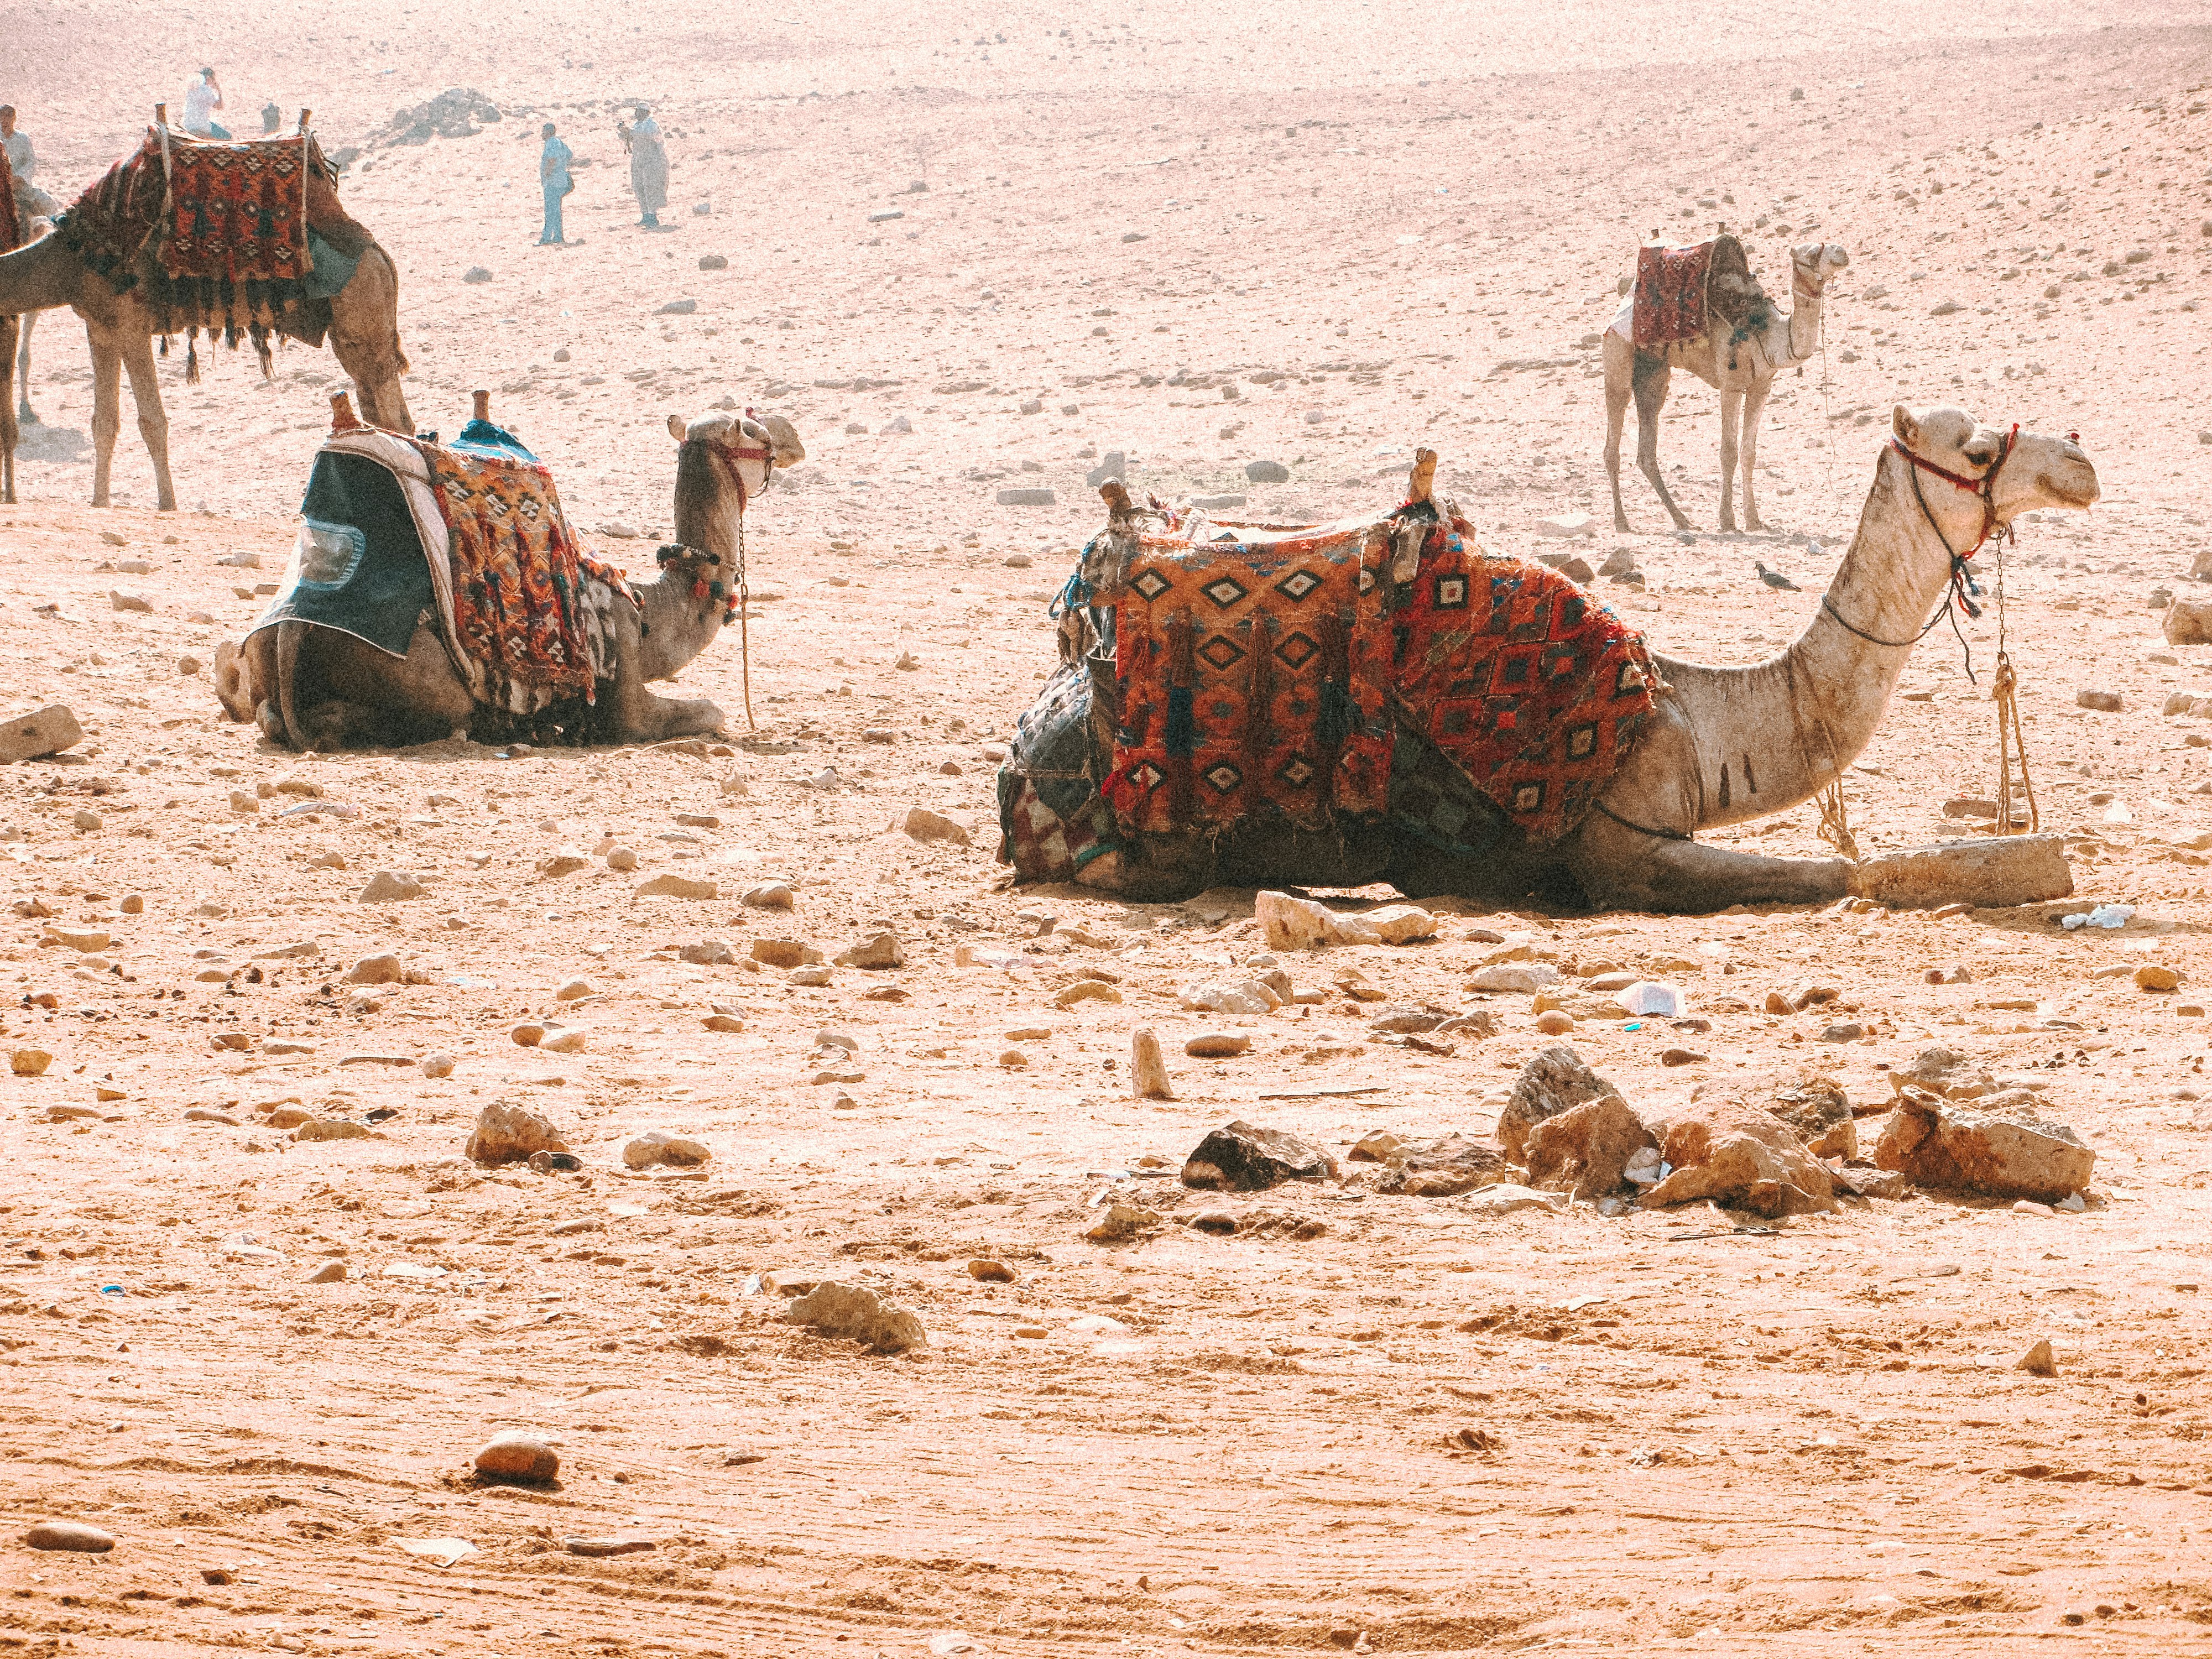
[{"left": 254, "top": 420, "right": 637, "bottom": 714}]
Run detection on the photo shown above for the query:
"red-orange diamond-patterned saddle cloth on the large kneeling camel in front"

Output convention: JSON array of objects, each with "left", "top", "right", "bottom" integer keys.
[{"left": 1086, "top": 507, "right": 1657, "bottom": 841}]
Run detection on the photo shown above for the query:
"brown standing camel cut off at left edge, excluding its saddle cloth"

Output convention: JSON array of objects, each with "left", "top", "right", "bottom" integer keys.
[{"left": 0, "top": 133, "right": 414, "bottom": 513}]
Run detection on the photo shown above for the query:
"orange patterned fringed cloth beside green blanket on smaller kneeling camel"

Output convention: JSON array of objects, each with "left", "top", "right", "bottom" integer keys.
[{"left": 276, "top": 420, "right": 637, "bottom": 714}]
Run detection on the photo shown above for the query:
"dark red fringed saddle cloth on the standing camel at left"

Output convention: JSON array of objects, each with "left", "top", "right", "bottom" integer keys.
[{"left": 58, "top": 133, "right": 369, "bottom": 345}]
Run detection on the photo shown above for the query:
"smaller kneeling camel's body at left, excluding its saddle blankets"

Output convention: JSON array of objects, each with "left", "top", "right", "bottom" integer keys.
[{"left": 215, "top": 405, "right": 807, "bottom": 750}]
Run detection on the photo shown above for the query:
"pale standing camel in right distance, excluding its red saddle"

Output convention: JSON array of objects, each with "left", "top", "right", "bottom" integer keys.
[{"left": 1604, "top": 241, "right": 1851, "bottom": 531}]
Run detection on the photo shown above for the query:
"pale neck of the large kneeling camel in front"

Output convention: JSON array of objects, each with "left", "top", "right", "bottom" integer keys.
[{"left": 1659, "top": 449, "right": 1951, "bottom": 830}]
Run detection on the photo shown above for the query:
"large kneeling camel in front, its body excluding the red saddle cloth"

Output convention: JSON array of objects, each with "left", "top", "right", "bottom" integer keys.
[{"left": 1000, "top": 405, "right": 2097, "bottom": 914}]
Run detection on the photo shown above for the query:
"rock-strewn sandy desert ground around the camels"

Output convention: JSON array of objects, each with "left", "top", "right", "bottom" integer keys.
[{"left": 0, "top": 0, "right": 2212, "bottom": 1657}]
